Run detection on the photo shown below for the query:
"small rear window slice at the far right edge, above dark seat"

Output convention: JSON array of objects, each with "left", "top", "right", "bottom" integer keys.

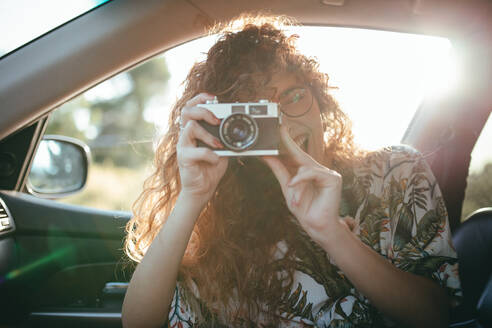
[{"left": 461, "top": 116, "right": 492, "bottom": 221}]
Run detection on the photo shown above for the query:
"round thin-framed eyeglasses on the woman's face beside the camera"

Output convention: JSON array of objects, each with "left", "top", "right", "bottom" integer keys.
[{"left": 278, "top": 86, "right": 314, "bottom": 117}]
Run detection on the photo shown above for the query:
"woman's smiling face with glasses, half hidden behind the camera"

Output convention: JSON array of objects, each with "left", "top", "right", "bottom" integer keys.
[{"left": 265, "top": 73, "right": 328, "bottom": 166}]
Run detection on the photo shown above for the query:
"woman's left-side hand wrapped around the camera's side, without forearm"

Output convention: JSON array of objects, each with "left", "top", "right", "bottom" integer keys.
[{"left": 177, "top": 93, "right": 228, "bottom": 202}]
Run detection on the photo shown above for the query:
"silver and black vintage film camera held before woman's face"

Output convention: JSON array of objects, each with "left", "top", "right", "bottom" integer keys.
[{"left": 197, "top": 98, "right": 281, "bottom": 156}]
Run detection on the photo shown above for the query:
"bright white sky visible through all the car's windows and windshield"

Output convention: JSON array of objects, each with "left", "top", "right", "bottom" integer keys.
[{"left": 0, "top": 0, "right": 492, "bottom": 171}]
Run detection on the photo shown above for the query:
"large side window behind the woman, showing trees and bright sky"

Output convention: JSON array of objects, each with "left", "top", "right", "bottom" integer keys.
[{"left": 36, "top": 27, "right": 454, "bottom": 210}]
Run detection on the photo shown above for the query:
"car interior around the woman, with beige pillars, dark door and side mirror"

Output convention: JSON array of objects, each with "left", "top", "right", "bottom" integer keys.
[{"left": 0, "top": 0, "right": 492, "bottom": 327}]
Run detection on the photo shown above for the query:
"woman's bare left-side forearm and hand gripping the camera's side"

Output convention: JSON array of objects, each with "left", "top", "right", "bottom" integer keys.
[{"left": 122, "top": 93, "right": 227, "bottom": 327}]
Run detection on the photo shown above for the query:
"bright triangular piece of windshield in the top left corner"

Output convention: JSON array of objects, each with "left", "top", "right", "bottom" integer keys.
[{"left": 0, "top": 0, "right": 109, "bottom": 57}]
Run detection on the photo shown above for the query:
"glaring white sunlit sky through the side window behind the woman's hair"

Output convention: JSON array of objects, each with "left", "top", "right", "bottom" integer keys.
[{"left": 159, "top": 27, "right": 456, "bottom": 150}]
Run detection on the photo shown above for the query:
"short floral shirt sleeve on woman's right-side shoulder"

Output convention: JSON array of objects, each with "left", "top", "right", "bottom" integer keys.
[{"left": 381, "top": 149, "right": 462, "bottom": 302}]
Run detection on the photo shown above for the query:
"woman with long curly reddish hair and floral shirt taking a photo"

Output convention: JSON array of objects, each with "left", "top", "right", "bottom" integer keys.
[{"left": 123, "top": 16, "right": 459, "bottom": 327}]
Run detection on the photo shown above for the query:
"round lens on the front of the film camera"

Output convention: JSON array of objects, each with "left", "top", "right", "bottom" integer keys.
[{"left": 219, "top": 113, "right": 258, "bottom": 152}]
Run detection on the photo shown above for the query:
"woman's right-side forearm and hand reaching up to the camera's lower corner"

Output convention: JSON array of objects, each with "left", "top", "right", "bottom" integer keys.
[{"left": 264, "top": 128, "right": 448, "bottom": 327}]
